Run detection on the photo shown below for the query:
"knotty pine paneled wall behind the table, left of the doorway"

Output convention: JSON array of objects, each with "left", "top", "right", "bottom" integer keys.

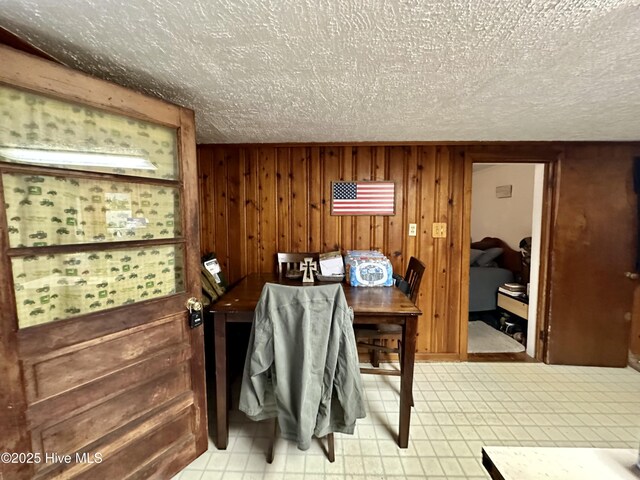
[{"left": 198, "top": 145, "right": 466, "bottom": 354}]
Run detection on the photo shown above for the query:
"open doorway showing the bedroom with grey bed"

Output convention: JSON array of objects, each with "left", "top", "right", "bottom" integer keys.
[{"left": 467, "top": 162, "right": 545, "bottom": 361}]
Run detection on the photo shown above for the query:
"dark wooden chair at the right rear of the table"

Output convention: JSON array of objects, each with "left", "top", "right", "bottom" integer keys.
[{"left": 356, "top": 257, "right": 426, "bottom": 376}]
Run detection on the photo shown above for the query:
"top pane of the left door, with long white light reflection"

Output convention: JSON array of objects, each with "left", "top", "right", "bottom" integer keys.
[{"left": 0, "top": 85, "right": 179, "bottom": 180}]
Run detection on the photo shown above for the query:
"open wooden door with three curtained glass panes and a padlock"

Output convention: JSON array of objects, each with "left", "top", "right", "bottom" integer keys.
[{"left": 0, "top": 47, "right": 207, "bottom": 478}]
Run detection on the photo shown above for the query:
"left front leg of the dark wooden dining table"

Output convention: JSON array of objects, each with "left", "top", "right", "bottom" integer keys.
[{"left": 213, "top": 314, "right": 229, "bottom": 450}]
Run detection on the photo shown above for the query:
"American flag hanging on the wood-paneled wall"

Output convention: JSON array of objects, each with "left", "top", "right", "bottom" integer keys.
[{"left": 331, "top": 182, "right": 395, "bottom": 215}]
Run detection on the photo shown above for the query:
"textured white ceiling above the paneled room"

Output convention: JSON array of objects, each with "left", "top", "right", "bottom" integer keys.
[{"left": 0, "top": 0, "right": 640, "bottom": 143}]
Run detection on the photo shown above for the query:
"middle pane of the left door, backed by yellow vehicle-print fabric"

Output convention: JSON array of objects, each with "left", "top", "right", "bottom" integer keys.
[{"left": 2, "top": 173, "right": 181, "bottom": 248}]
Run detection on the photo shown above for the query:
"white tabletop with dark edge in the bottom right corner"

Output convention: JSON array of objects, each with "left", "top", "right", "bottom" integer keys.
[{"left": 482, "top": 447, "right": 640, "bottom": 480}]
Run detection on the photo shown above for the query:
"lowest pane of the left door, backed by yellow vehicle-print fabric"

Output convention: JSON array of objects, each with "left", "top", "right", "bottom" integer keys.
[{"left": 11, "top": 245, "right": 184, "bottom": 328}]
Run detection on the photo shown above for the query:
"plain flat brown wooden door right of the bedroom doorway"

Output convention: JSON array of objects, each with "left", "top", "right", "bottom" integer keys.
[{"left": 545, "top": 144, "right": 637, "bottom": 367}]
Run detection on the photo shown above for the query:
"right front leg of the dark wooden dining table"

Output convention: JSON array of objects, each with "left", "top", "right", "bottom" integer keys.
[{"left": 398, "top": 316, "right": 418, "bottom": 448}]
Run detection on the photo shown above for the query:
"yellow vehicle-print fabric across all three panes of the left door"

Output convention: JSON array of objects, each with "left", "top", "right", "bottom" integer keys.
[{"left": 0, "top": 86, "right": 184, "bottom": 328}]
